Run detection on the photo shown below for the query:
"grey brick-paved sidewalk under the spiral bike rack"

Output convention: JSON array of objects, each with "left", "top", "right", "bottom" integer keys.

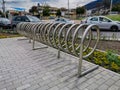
[{"left": 0, "top": 37, "right": 120, "bottom": 90}]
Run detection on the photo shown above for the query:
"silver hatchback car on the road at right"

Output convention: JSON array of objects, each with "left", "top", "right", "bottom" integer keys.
[{"left": 81, "top": 16, "right": 120, "bottom": 31}]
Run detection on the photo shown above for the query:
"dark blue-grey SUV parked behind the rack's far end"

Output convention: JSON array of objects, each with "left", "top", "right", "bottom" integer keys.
[{"left": 12, "top": 15, "right": 41, "bottom": 29}]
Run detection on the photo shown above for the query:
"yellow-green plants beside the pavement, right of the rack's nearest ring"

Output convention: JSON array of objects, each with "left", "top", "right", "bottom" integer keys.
[{"left": 86, "top": 50, "right": 120, "bottom": 73}]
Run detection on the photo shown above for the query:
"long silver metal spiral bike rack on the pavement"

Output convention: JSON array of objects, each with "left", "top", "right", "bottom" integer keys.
[{"left": 17, "top": 22, "right": 100, "bottom": 77}]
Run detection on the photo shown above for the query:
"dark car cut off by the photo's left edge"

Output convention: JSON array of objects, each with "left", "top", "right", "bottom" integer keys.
[{"left": 0, "top": 18, "right": 11, "bottom": 30}]
